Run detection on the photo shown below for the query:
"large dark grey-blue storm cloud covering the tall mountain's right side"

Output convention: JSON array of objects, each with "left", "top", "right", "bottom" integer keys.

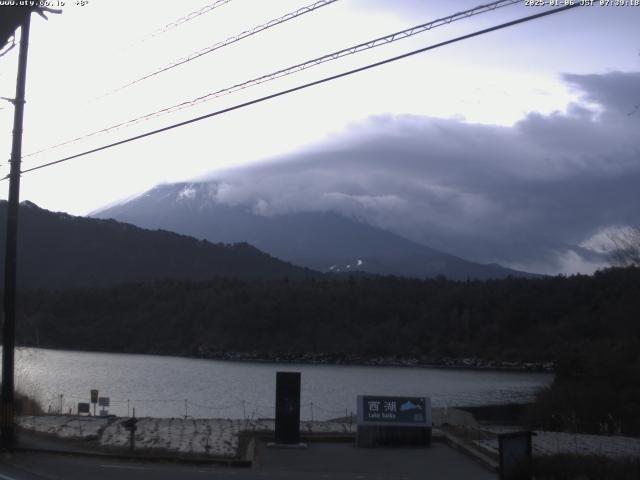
[{"left": 204, "top": 72, "right": 640, "bottom": 272}]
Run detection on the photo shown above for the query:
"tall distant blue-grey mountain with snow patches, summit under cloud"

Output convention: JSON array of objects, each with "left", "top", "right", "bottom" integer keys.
[{"left": 92, "top": 182, "right": 533, "bottom": 280}]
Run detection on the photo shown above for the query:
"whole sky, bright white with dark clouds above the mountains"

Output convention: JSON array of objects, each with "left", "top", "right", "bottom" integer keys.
[{"left": 0, "top": 0, "right": 640, "bottom": 273}]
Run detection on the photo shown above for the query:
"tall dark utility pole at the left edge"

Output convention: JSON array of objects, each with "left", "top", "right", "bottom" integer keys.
[{"left": 0, "top": 12, "right": 31, "bottom": 450}]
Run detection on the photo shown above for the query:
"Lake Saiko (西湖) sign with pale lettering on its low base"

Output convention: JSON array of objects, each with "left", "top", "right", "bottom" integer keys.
[{"left": 356, "top": 395, "right": 432, "bottom": 447}]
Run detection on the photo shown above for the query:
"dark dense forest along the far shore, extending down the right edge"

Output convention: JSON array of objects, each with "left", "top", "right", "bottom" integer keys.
[{"left": 6, "top": 267, "right": 640, "bottom": 433}]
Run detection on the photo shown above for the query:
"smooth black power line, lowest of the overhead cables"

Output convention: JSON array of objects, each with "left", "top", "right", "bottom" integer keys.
[{"left": 8, "top": 4, "right": 580, "bottom": 180}]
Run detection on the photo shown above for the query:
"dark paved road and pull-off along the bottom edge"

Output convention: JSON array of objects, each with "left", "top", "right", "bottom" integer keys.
[{"left": 0, "top": 443, "right": 497, "bottom": 480}]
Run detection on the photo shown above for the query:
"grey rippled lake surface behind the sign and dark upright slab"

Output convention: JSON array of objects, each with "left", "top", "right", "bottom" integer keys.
[{"left": 10, "top": 348, "right": 553, "bottom": 420}]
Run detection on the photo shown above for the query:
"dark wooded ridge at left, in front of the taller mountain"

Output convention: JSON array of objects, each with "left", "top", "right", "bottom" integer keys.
[{"left": 0, "top": 201, "right": 315, "bottom": 288}]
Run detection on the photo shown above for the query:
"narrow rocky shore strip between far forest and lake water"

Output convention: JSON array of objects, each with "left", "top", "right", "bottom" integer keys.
[{"left": 196, "top": 347, "right": 555, "bottom": 372}]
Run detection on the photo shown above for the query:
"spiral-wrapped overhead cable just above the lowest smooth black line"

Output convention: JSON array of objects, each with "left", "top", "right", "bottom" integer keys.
[{"left": 24, "top": 0, "right": 520, "bottom": 158}]
